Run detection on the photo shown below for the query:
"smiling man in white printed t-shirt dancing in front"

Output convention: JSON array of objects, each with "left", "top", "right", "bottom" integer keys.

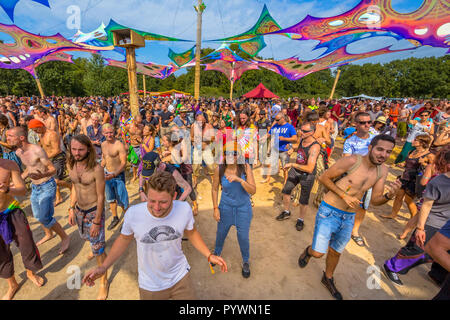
[{"left": 83, "top": 172, "right": 227, "bottom": 300}]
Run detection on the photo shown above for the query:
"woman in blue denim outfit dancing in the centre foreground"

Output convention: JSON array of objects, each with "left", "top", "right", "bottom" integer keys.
[{"left": 212, "top": 148, "right": 256, "bottom": 278}]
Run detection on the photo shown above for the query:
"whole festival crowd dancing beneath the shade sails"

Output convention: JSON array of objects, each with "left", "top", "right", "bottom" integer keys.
[{"left": 0, "top": 97, "right": 450, "bottom": 300}]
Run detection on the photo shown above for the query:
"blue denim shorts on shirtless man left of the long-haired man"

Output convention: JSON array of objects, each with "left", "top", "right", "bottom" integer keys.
[{"left": 30, "top": 178, "right": 56, "bottom": 229}]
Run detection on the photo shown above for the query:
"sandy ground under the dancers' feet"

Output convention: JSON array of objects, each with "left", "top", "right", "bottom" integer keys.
[{"left": 0, "top": 142, "right": 439, "bottom": 300}]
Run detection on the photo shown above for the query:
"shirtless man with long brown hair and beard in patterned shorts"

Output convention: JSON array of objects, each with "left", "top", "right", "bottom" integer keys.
[{"left": 68, "top": 135, "right": 108, "bottom": 300}]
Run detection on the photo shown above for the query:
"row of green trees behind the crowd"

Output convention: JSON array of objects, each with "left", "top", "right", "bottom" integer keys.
[{"left": 0, "top": 51, "right": 450, "bottom": 98}]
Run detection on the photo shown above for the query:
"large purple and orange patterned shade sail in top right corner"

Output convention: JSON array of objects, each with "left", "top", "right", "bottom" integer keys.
[{"left": 273, "top": 0, "right": 450, "bottom": 48}]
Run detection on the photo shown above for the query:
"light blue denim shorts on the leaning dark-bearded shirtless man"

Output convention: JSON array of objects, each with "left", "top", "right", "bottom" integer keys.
[{"left": 312, "top": 201, "right": 355, "bottom": 253}]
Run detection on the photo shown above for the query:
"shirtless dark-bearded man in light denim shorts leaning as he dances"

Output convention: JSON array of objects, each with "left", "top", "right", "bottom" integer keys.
[{"left": 298, "top": 135, "right": 401, "bottom": 300}]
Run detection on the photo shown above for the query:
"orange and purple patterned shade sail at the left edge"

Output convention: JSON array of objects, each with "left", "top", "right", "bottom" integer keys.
[{"left": 0, "top": 24, "right": 95, "bottom": 69}]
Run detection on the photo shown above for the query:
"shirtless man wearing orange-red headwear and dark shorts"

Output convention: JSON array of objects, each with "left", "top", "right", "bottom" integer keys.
[{"left": 28, "top": 119, "right": 71, "bottom": 207}]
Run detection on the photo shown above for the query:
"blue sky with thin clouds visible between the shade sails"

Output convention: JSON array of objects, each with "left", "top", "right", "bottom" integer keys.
[{"left": 0, "top": 0, "right": 447, "bottom": 77}]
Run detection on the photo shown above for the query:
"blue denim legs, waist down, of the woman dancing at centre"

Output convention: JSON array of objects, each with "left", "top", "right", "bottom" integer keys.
[{"left": 214, "top": 203, "right": 253, "bottom": 262}]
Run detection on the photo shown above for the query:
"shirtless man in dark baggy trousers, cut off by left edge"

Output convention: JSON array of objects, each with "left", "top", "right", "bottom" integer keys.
[{"left": 0, "top": 159, "right": 44, "bottom": 300}]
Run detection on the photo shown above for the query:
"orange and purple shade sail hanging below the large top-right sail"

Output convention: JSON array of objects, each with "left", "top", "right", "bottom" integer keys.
[{"left": 255, "top": 46, "right": 416, "bottom": 80}]
